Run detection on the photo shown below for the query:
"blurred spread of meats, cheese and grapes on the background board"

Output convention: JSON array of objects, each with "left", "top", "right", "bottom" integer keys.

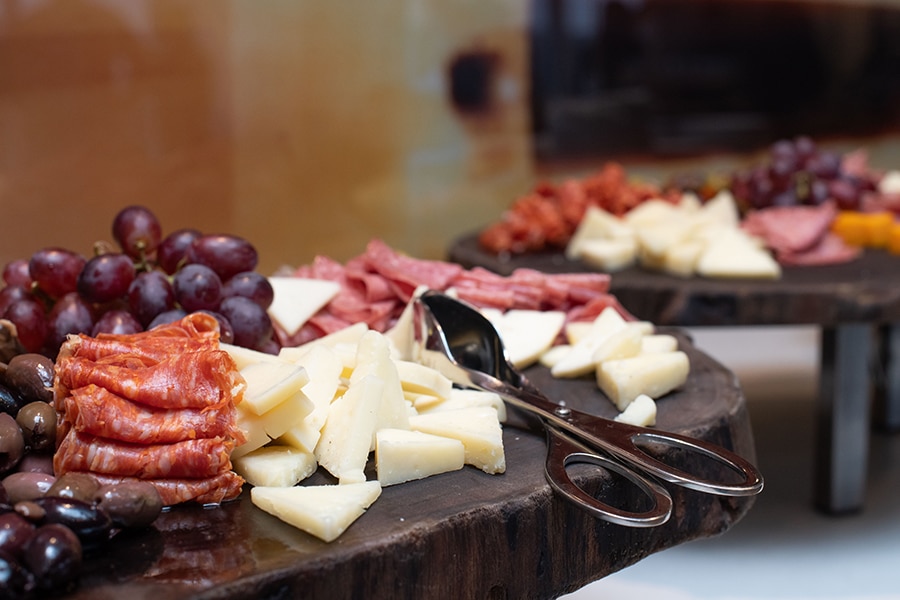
[{"left": 478, "top": 137, "right": 900, "bottom": 278}]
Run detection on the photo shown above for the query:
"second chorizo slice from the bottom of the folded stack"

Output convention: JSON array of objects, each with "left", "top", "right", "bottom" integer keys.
[{"left": 53, "top": 431, "right": 234, "bottom": 479}]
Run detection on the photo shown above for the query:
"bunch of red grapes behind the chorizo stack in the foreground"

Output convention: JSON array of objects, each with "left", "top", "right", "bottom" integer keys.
[{"left": 0, "top": 206, "right": 277, "bottom": 358}]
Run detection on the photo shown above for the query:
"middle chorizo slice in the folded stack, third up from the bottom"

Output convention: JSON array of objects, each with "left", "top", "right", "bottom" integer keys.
[{"left": 63, "top": 384, "right": 244, "bottom": 444}]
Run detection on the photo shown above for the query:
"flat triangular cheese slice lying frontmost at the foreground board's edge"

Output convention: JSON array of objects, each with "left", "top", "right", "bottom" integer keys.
[{"left": 250, "top": 481, "right": 381, "bottom": 542}]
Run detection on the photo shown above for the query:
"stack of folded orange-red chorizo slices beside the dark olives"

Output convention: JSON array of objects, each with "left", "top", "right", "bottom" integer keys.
[{"left": 53, "top": 313, "right": 246, "bottom": 506}]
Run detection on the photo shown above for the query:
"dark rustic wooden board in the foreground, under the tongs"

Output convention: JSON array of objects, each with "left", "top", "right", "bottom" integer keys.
[{"left": 66, "top": 332, "right": 755, "bottom": 600}]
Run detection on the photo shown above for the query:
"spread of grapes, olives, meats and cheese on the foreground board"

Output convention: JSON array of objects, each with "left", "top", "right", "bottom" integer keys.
[{"left": 0, "top": 207, "right": 704, "bottom": 598}]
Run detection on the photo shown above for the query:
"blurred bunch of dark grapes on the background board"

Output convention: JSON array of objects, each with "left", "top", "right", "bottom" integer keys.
[{"left": 730, "top": 136, "right": 877, "bottom": 210}]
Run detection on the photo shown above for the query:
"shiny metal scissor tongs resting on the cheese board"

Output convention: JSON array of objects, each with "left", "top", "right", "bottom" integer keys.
[{"left": 413, "top": 291, "right": 763, "bottom": 527}]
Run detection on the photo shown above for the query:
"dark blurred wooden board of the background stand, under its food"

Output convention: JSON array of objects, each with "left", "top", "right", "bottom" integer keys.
[{"left": 449, "top": 234, "right": 900, "bottom": 327}]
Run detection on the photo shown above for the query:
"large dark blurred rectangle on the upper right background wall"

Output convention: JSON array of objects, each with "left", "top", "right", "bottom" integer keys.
[{"left": 531, "top": 0, "right": 900, "bottom": 160}]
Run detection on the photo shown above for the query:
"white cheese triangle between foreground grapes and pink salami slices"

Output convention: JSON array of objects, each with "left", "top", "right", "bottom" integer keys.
[{"left": 268, "top": 277, "right": 341, "bottom": 335}]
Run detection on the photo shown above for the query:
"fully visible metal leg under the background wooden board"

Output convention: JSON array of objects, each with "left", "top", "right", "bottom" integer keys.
[{"left": 814, "top": 324, "right": 872, "bottom": 514}]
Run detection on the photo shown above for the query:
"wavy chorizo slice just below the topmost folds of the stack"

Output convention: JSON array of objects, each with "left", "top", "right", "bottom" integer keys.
[{"left": 56, "top": 350, "right": 246, "bottom": 408}]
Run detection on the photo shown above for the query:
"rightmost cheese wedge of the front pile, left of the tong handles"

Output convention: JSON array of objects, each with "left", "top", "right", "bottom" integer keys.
[{"left": 409, "top": 406, "right": 506, "bottom": 473}]
